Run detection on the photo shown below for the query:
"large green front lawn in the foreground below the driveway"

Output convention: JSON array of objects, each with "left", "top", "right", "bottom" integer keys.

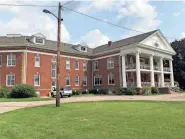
[{"left": 0, "top": 101, "right": 185, "bottom": 139}]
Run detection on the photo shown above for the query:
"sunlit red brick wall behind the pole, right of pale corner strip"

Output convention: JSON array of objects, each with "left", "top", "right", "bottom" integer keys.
[{"left": 26, "top": 53, "right": 92, "bottom": 96}]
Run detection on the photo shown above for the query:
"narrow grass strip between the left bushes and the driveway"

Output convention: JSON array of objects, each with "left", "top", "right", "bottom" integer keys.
[{"left": 0, "top": 97, "right": 53, "bottom": 102}]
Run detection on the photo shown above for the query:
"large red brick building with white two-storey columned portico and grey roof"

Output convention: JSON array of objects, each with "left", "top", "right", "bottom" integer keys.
[{"left": 0, "top": 30, "right": 175, "bottom": 96}]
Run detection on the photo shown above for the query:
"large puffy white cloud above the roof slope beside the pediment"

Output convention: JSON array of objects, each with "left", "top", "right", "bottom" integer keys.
[{"left": 117, "top": 0, "right": 161, "bottom": 38}]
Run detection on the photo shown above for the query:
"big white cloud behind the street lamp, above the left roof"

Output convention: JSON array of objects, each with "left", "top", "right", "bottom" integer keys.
[{"left": 0, "top": 2, "right": 70, "bottom": 42}]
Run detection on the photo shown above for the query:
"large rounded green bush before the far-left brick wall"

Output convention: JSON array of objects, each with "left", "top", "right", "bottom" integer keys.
[{"left": 9, "top": 84, "right": 37, "bottom": 98}]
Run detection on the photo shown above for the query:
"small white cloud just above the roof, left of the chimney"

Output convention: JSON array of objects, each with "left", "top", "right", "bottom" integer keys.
[{"left": 80, "top": 29, "right": 109, "bottom": 48}]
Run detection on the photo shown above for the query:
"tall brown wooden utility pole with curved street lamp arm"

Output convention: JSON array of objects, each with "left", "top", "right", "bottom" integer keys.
[{"left": 43, "top": 2, "right": 63, "bottom": 107}]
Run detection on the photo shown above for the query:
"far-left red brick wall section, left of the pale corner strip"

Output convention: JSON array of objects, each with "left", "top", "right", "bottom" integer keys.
[{"left": 0, "top": 52, "right": 23, "bottom": 86}]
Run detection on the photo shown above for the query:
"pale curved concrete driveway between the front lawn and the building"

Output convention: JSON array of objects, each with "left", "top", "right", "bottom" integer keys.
[{"left": 0, "top": 94, "right": 185, "bottom": 113}]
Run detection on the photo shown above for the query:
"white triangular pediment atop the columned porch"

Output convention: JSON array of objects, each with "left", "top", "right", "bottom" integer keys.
[{"left": 140, "top": 30, "right": 175, "bottom": 54}]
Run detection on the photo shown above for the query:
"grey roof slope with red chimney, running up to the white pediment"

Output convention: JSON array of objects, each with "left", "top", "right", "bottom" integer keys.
[{"left": 93, "top": 30, "right": 158, "bottom": 53}]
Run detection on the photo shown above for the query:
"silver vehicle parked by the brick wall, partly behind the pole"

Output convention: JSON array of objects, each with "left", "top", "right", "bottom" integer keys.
[{"left": 51, "top": 87, "right": 73, "bottom": 97}]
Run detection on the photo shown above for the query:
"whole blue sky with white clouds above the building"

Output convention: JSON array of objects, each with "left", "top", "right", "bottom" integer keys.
[{"left": 0, "top": 0, "right": 185, "bottom": 48}]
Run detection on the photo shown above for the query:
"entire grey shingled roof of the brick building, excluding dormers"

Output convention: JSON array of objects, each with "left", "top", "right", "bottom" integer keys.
[{"left": 0, "top": 30, "right": 158, "bottom": 56}]
